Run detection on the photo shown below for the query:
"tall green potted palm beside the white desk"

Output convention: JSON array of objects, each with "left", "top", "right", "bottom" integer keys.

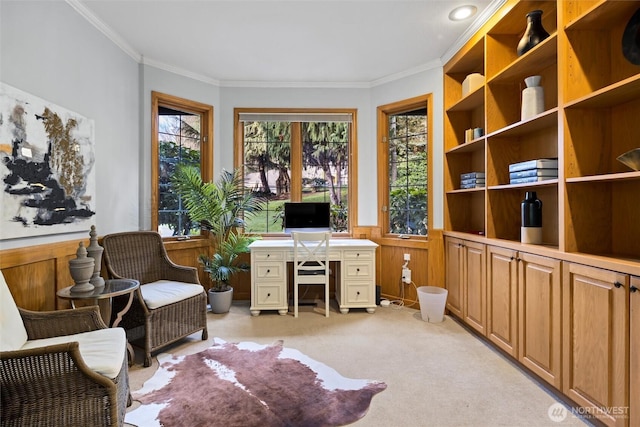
[{"left": 172, "top": 166, "right": 264, "bottom": 313}]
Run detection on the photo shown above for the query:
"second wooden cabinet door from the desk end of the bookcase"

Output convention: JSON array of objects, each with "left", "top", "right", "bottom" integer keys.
[{"left": 462, "top": 241, "right": 487, "bottom": 335}]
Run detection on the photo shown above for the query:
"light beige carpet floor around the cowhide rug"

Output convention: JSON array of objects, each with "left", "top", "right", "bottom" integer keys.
[{"left": 129, "top": 301, "right": 588, "bottom": 427}]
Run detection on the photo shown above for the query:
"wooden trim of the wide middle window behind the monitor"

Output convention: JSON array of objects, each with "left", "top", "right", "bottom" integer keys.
[{"left": 233, "top": 107, "right": 358, "bottom": 237}]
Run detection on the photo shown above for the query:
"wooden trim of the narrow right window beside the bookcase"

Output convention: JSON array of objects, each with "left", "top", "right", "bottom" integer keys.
[{"left": 377, "top": 93, "right": 433, "bottom": 240}]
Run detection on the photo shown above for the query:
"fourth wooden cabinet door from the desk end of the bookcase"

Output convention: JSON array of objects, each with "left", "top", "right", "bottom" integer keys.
[{"left": 518, "top": 252, "right": 562, "bottom": 390}]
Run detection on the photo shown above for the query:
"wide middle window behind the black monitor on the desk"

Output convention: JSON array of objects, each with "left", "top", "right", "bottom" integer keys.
[{"left": 235, "top": 109, "right": 356, "bottom": 233}]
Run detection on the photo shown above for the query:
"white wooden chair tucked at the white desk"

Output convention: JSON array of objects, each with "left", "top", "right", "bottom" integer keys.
[{"left": 291, "top": 231, "right": 331, "bottom": 317}]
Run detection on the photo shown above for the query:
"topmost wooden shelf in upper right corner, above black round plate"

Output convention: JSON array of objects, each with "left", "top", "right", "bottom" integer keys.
[{"left": 564, "top": 0, "right": 640, "bottom": 31}]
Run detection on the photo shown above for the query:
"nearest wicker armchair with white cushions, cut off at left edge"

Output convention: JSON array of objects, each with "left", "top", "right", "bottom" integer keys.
[{"left": 0, "top": 274, "right": 130, "bottom": 427}]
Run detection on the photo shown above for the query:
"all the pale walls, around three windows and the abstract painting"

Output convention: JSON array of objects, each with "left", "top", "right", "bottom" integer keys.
[{"left": 0, "top": 0, "right": 443, "bottom": 249}]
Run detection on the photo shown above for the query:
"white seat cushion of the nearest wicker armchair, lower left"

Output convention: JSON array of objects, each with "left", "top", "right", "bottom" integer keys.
[{"left": 22, "top": 328, "right": 127, "bottom": 379}]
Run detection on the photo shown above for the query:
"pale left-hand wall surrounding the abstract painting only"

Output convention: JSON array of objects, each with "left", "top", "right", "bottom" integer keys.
[{"left": 0, "top": 1, "right": 140, "bottom": 249}]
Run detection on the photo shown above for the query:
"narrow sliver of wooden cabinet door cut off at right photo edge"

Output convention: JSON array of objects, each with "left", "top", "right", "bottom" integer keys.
[{"left": 629, "top": 276, "right": 640, "bottom": 426}]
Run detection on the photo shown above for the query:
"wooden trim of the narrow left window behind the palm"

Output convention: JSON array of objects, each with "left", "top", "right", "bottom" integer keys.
[{"left": 151, "top": 91, "right": 213, "bottom": 240}]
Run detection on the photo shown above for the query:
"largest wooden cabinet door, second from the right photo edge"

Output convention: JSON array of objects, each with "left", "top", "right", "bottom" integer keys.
[{"left": 562, "top": 263, "right": 638, "bottom": 426}]
